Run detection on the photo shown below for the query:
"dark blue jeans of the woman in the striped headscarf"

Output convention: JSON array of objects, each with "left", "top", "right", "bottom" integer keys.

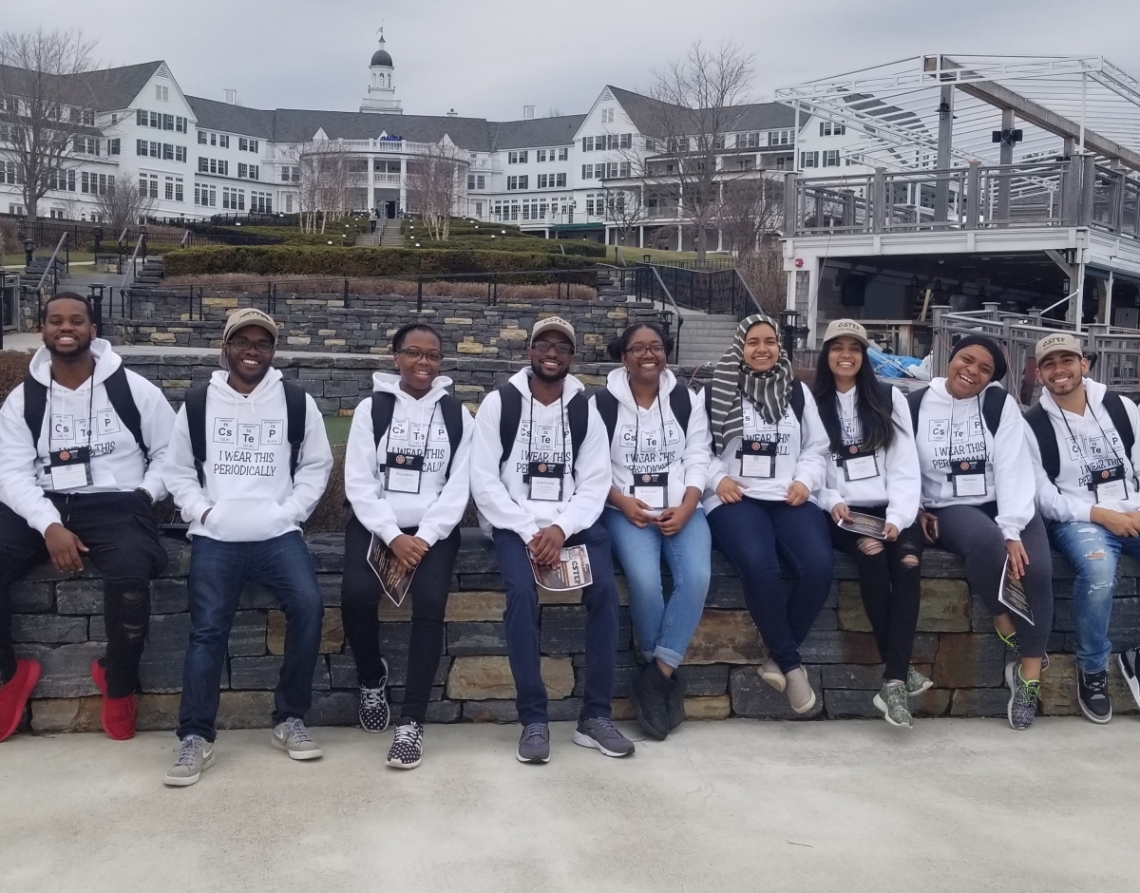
[{"left": 709, "top": 496, "right": 834, "bottom": 673}]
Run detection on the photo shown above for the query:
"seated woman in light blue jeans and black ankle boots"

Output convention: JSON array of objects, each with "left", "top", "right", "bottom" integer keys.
[{"left": 594, "top": 323, "right": 713, "bottom": 740}]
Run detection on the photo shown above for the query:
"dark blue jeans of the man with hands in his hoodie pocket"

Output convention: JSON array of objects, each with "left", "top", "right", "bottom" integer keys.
[{"left": 178, "top": 530, "right": 325, "bottom": 741}]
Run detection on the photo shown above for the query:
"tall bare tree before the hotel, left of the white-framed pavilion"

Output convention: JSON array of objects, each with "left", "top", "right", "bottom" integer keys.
[{"left": 638, "top": 40, "right": 752, "bottom": 261}]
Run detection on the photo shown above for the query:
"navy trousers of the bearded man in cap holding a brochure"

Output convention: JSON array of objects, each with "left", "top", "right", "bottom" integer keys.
[{"left": 492, "top": 521, "right": 618, "bottom": 725}]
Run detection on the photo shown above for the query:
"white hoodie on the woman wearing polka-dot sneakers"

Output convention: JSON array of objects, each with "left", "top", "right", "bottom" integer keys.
[{"left": 344, "top": 372, "right": 475, "bottom": 545}]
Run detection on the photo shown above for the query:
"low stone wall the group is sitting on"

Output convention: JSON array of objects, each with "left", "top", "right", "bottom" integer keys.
[{"left": 11, "top": 530, "right": 1140, "bottom": 732}]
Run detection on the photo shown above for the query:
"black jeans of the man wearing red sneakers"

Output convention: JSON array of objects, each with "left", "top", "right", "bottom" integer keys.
[{"left": 0, "top": 490, "right": 166, "bottom": 698}]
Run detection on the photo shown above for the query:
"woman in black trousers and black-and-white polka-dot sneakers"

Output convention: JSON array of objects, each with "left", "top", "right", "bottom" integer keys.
[{"left": 341, "top": 323, "right": 474, "bottom": 769}]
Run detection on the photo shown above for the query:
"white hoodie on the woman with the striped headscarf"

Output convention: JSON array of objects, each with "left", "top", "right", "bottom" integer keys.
[{"left": 701, "top": 385, "right": 828, "bottom": 512}]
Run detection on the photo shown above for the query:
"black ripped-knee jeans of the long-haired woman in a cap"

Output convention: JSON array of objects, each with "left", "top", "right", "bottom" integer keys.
[{"left": 831, "top": 505, "right": 922, "bottom": 680}]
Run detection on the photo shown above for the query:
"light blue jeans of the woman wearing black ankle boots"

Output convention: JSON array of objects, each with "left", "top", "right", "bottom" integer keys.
[{"left": 602, "top": 508, "right": 713, "bottom": 667}]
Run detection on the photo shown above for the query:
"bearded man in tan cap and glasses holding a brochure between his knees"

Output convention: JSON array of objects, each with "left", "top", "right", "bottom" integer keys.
[{"left": 471, "top": 316, "right": 634, "bottom": 763}]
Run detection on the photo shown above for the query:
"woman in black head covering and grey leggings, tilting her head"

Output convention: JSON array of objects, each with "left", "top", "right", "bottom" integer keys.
[{"left": 907, "top": 335, "right": 1053, "bottom": 730}]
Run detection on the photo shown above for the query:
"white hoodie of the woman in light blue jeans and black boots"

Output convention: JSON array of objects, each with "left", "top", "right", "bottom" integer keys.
[{"left": 591, "top": 367, "right": 713, "bottom": 515}]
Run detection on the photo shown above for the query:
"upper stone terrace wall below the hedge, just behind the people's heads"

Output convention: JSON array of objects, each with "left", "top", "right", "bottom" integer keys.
[{"left": 104, "top": 291, "right": 660, "bottom": 362}]
